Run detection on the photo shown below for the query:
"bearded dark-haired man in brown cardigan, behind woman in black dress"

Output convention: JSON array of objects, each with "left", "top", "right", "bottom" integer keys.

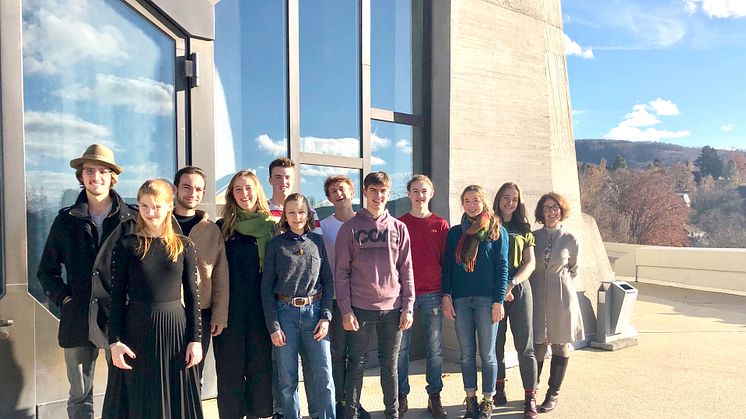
[{"left": 174, "top": 166, "right": 228, "bottom": 377}]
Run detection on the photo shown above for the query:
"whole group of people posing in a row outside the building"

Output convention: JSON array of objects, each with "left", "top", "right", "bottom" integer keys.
[{"left": 38, "top": 144, "right": 584, "bottom": 419}]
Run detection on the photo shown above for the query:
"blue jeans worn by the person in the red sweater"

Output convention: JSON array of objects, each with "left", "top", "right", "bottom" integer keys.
[{"left": 399, "top": 292, "right": 443, "bottom": 394}]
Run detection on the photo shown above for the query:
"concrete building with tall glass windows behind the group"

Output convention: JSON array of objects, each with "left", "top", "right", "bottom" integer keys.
[{"left": 0, "top": 0, "right": 613, "bottom": 418}]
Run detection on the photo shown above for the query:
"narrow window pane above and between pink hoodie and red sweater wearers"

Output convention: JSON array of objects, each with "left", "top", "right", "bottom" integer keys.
[{"left": 370, "top": 121, "right": 416, "bottom": 217}]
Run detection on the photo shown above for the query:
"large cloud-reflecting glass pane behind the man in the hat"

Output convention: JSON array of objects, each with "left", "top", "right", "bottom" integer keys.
[{"left": 23, "top": 0, "right": 176, "bottom": 316}]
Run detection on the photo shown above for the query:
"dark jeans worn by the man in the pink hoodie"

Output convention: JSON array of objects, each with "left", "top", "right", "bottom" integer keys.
[{"left": 345, "top": 307, "right": 402, "bottom": 419}]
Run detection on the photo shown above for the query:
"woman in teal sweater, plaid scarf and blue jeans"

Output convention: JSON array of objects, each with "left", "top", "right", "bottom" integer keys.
[{"left": 443, "top": 185, "right": 508, "bottom": 418}]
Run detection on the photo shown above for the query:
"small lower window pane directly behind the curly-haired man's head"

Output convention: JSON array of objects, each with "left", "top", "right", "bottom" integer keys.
[{"left": 300, "top": 164, "right": 362, "bottom": 220}]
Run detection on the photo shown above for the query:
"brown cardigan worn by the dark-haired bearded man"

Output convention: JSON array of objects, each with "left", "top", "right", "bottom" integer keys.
[{"left": 177, "top": 210, "right": 229, "bottom": 327}]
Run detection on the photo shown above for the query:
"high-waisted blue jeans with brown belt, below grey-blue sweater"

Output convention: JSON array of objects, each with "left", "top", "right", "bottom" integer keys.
[{"left": 274, "top": 301, "right": 335, "bottom": 419}]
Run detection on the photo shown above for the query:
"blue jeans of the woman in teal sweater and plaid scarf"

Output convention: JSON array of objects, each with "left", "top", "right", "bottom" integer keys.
[{"left": 453, "top": 296, "right": 498, "bottom": 397}]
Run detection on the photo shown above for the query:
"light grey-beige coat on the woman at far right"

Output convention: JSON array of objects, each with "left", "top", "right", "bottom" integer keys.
[{"left": 530, "top": 227, "right": 585, "bottom": 344}]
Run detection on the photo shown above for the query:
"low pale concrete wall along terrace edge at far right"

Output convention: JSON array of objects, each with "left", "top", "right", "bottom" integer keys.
[{"left": 604, "top": 243, "right": 746, "bottom": 295}]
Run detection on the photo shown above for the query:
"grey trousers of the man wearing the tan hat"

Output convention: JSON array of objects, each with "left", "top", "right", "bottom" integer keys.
[{"left": 64, "top": 346, "right": 114, "bottom": 419}]
